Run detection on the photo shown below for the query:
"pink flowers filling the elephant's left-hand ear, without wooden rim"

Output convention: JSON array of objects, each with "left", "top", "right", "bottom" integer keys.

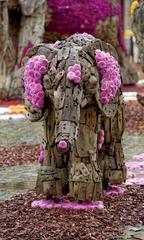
[{"left": 24, "top": 55, "right": 48, "bottom": 108}]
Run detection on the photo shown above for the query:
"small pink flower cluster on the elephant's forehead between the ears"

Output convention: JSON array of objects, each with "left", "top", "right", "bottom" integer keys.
[{"left": 67, "top": 64, "right": 81, "bottom": 84}]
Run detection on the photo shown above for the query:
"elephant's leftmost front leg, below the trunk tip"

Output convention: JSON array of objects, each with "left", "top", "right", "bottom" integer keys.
[{"left": 36, "top": 149, "right": 68, "bottom": 198}]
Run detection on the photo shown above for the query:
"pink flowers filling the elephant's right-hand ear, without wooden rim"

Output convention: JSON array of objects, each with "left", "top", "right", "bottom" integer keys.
[{"left": 95, "top": 49, "right": 121, "bottom": 104}]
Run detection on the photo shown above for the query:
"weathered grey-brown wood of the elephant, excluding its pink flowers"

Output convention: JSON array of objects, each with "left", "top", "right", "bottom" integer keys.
[{"left": 23, "top": 34, "right": 126, "bottom": 201}]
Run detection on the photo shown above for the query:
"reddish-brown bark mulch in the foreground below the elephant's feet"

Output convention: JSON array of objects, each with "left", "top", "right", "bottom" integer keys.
[{"left": 0, "top": 186, "right": 144, "bottom": 240}]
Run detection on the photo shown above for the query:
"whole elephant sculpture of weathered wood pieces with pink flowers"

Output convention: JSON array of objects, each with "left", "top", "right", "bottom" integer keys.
[{"left": 23, "top": 33, "right": 126, "bottom": 201}]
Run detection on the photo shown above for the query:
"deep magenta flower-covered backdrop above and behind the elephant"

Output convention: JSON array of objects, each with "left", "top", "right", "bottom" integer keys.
[{"left": 46, "top": 0, "right": 127, "bottom": 52}]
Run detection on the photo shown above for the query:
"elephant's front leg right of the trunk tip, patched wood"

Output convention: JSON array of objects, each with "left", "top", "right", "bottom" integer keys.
[{"left": 68, "top": 150, "right": 102, "bottom": 201}]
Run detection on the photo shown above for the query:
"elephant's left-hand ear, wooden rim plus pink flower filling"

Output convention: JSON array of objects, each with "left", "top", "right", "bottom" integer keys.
[{"left": 23, "top": 44, "right": 58, "bottom": 118}]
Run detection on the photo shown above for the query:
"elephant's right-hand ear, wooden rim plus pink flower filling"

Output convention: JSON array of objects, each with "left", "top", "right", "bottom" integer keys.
[{"left": 83, "top": 39, "right": 123, "bottom": 117}]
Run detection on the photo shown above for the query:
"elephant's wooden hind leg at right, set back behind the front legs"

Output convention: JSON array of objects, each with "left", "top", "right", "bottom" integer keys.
[{"left": 98, "top": 106, "right": 126, "bottom": 187}]
